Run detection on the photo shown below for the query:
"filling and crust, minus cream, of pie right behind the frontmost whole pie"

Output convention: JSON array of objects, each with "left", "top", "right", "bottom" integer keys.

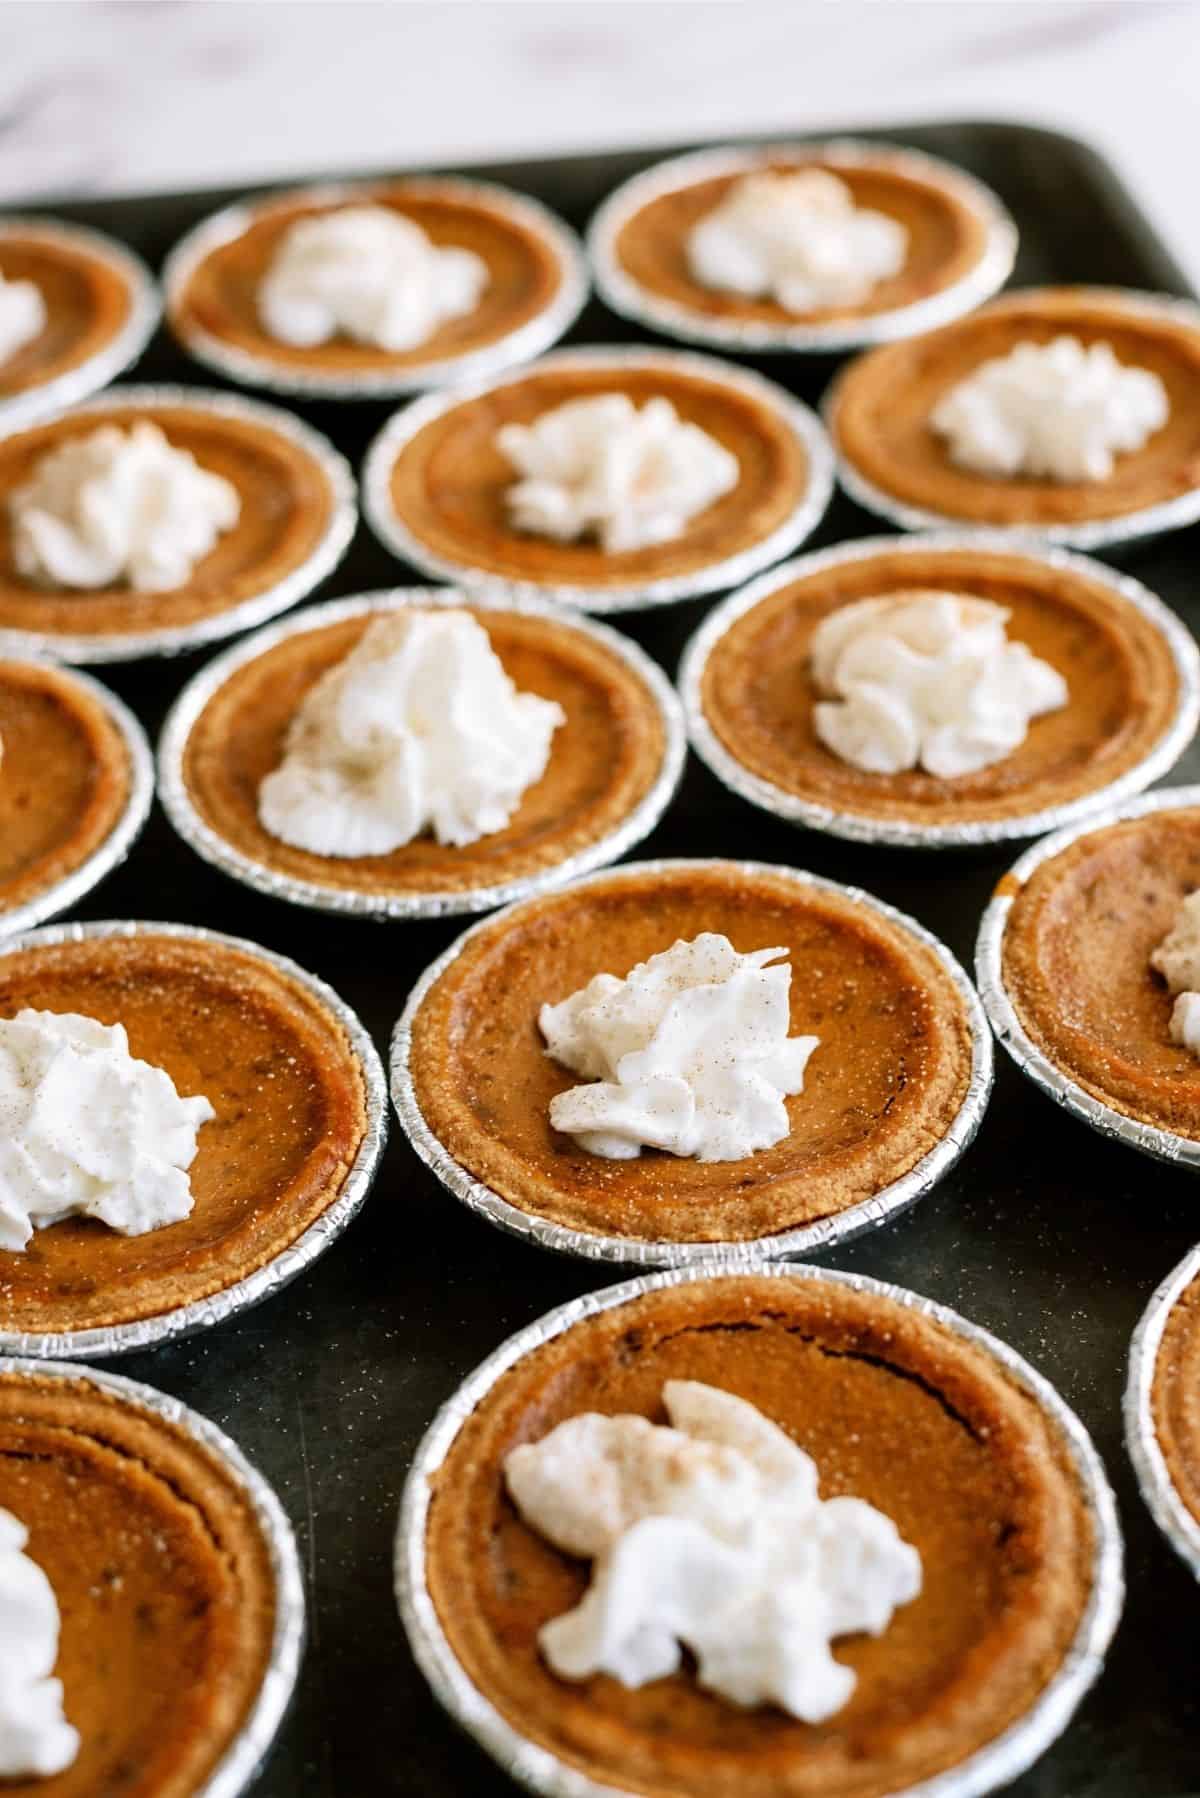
[{"left": 410, "top": 863, "right": 972, "bottom": 1242}]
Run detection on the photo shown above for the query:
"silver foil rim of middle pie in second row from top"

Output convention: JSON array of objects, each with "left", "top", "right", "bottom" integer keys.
[{"left": 360, "top": 343, "right": 833, "bottom": 613}]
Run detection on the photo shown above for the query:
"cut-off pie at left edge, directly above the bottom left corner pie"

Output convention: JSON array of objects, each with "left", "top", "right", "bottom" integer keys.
[{"left": 0, "top": 924, "right": 381, "bottom": 1354}]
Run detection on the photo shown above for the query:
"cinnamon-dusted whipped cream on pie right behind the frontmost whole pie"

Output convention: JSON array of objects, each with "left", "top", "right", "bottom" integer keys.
[{"left": 538, "top": 931, "right": 820, "bottom": 1162}]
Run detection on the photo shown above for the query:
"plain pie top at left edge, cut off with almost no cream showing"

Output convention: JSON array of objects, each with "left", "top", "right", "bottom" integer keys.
[{"left": 0, "top": 662, "right": 131, "bottom": 919}]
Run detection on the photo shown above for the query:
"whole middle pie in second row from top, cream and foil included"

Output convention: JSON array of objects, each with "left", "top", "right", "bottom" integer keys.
[{"left": 363, "top": 349, "right": 831, "bottom": 611}]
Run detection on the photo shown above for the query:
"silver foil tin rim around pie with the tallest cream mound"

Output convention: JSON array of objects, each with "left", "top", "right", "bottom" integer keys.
[{"left": 158, "top": 586, "right": 687, "bottom": 919}]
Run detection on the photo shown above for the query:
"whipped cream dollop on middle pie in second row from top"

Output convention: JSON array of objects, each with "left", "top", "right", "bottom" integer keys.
[{"left": 497, "top": 394, "right": 739, "bottom": 554}]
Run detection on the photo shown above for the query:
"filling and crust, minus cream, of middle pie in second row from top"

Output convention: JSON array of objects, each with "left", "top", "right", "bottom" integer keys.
[{"left": 389, "top": 358, "right": 810, "bottom": 588}]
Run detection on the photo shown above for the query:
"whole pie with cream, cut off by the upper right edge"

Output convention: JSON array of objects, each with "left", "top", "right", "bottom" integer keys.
[{"left": 826, "top": 288, "right": 1200, "bottom": 548}]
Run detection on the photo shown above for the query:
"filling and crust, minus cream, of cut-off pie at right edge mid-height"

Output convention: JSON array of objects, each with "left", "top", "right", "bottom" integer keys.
[{"left": 1002, "top": 807, "right": 1200, "bottom": 1138}]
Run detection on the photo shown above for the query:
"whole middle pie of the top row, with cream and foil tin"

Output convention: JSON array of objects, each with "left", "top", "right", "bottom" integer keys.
[{"left": 164, "top": 176, "right": 587, "bottom": 399}]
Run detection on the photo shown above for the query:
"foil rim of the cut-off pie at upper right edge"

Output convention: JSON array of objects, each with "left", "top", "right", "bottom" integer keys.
[{"left": 820, "top": 284, "right": 1200, "bottom": 550}]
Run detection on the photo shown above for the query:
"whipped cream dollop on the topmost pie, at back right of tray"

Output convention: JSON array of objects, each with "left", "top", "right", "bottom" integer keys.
[{"left": 687, "top": 169, "right": 909, "bottom": 313}]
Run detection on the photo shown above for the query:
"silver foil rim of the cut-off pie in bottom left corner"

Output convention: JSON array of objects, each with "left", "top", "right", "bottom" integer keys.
[{"left": 0, "top": 1357, "right": 304, "bottom": 1798}]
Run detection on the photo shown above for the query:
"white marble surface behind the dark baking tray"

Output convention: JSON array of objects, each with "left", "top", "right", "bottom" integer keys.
[{"left": 0, "top": 0, "right": 1200, "bottom": 282}]
